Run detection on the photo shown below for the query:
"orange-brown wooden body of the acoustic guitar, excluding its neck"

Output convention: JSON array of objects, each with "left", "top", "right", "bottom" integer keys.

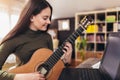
[{"left": 8, "top": 48, "right": 64, "bottom": 80}]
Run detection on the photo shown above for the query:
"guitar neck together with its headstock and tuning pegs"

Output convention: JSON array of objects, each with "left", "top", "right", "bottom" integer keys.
[{"left": 44, "top": 16, "right": 93, "bottom": 70}]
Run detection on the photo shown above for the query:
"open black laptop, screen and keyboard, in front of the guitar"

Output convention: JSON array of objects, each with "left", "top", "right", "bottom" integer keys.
[{"left": 58, "top": 32, "right": 120, "bottom": 80}]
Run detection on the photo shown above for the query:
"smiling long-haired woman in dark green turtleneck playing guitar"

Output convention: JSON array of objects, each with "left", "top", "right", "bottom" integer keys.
[{"left": 0, "top": 0, "right": 72, "bottom": 80}]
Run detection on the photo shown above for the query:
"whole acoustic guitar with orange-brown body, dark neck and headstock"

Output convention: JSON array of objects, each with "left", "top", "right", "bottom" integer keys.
[{"left": 8, "top": 16, "right": 93, "bottom": 80}]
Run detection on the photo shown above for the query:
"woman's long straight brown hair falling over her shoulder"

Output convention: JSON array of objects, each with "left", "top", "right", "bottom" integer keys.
[{"left": 0, "top": 0, "right": 52, "bottom": 44}]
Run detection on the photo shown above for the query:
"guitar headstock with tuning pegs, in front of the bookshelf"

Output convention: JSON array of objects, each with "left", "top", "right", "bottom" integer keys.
[{"left": 79, "top": 16, "right": 93, "bottom": 29}]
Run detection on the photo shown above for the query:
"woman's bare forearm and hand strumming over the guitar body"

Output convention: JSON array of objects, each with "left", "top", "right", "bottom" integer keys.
[{"left": 14, "top": 72, "right": 45, "bottom": 80}]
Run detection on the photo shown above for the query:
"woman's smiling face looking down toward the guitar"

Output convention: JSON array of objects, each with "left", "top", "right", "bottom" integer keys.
[{"left": 30, "top": 7, "right": 51, "bottom": 31}]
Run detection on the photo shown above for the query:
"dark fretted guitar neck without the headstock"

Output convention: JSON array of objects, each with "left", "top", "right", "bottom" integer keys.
[{"left": 44, "top": 24, "right": 84, "bottom": 69}]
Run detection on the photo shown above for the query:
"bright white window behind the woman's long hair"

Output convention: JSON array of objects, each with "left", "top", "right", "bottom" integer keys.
[{"left": 0, "top": 10, "right": 18, "bottom": 39}]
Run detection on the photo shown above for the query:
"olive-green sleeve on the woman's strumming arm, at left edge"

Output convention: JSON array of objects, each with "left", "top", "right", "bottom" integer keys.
[{"left": 0, "top": 42, "right": 15, "bottom": 80}]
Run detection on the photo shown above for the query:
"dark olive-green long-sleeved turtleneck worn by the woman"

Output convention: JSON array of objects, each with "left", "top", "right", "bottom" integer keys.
[{"left": 0, "top": 30, "right": 53, "bottom": 80}]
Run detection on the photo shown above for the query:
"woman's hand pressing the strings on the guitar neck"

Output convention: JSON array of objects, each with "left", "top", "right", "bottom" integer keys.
[{"left": 62, "top": 42, "right": 73, "bottom": 64}]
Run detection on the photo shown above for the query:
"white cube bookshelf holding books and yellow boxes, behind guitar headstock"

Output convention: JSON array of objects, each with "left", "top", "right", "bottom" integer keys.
[{"left": 75, "top": 9, "right": 120, "bottom": 61}]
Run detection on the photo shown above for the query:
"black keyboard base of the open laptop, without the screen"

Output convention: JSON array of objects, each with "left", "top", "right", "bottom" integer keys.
[{"left": 59, "top": 68, "right": 111, "bottom": 80}]
